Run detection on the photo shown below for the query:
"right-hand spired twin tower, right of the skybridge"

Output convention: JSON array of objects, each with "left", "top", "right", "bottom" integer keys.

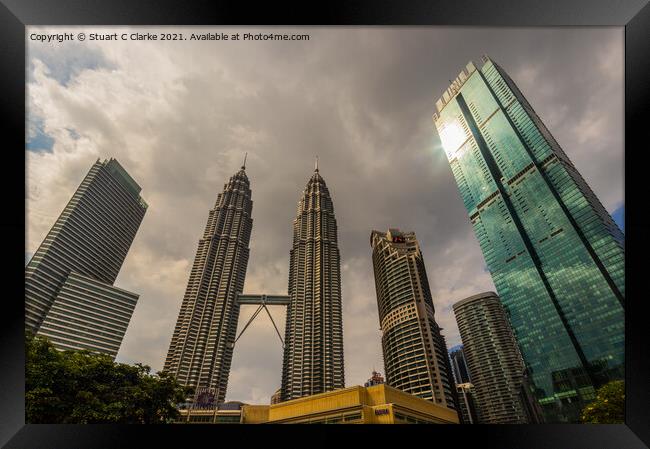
[{"left": 282, "top": 165, "right": 345, "bottom": 401}]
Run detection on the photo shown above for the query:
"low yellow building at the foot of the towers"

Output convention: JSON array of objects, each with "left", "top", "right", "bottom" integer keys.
[{"left": 181, "top": 384, "right": 458, "bottom": 424}]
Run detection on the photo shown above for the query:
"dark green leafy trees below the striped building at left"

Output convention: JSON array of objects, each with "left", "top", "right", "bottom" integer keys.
[{"left": 25, "top": 336, "right": 191, "bottom": 424}]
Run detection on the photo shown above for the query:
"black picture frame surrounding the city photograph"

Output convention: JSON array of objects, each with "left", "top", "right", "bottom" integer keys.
[{"left": 0, "top": 0, "right": 650, "bottom": 449}]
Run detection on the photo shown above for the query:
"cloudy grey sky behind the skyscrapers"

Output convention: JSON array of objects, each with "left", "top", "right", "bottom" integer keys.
[{"left": 25, "top": 27, "right": 624, "bottom": 403}]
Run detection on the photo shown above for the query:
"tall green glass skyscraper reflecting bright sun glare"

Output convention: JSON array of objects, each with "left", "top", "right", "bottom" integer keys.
[{"left": 433, "top": 57, "right": 625, "bottom": 422}]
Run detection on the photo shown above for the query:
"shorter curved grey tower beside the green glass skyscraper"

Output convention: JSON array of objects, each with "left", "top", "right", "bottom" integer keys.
[{"left": 453, "top": 292, "right": 527, "bottom": 424}]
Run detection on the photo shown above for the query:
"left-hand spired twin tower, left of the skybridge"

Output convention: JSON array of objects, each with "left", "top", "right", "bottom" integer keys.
[{"left": 164, "top": 161, "right": 253, "bottom": 404}]
